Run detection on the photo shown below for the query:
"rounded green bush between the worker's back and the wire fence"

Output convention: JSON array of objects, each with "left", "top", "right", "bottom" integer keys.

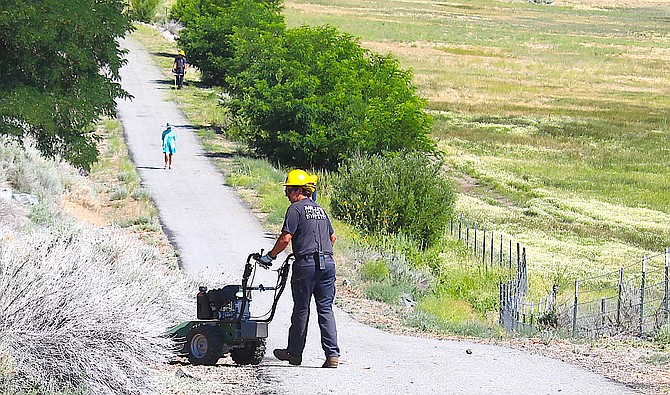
[{"left": 331, "top": 152, "right": 455, "bottom": 247}]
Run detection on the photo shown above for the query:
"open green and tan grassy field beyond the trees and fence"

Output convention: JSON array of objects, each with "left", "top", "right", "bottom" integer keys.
[{"left": 284, "top": 0, "right": 670, "bottom": 283}]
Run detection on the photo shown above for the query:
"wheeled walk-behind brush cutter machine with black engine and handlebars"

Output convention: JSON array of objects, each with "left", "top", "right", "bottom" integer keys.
[{"left": 168, "top": 251, "right": 293, "bottom": 365}]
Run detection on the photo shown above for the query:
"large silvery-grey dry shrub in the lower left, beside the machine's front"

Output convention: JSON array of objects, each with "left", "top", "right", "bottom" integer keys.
[{"left": 0, "top": 225, "right": 192, "bottom": 394}]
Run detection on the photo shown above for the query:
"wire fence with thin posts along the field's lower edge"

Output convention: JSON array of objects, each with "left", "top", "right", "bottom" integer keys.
[{"left": 450, "top": 215, "right": 670, "bottom": 337}]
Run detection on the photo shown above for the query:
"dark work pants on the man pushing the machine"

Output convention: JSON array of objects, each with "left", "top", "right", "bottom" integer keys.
[{"left": 288, "top": 255, "right": 340, "bottom": 358}]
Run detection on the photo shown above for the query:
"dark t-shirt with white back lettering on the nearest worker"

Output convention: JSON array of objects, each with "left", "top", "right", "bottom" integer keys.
[{"left": 282, "top": 198, "right": 335, "bottom": 256}]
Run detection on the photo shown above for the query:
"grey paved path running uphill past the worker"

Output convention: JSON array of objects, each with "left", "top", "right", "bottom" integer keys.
[{"left": 118, "top": 40, "right": 635, "bottom": 395}]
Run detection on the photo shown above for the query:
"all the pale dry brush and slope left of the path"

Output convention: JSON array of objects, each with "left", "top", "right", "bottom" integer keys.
[{"left": 0, "top": 125, "right": 189, "bottom": 395}]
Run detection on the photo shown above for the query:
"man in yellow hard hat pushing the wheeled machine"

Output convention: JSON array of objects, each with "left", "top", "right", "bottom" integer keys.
[{"left": 259, "top": 169, "right": 340, "bottom": 368}]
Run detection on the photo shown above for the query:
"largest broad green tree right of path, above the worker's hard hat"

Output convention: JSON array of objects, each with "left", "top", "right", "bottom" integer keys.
[{"left": 228, "top": 26, "right": 433, "bottom": 169}]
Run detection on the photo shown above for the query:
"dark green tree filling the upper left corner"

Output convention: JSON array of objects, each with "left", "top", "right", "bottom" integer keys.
[{"left": 0, "top": 0, "right": 132, "bottom": 168}]
